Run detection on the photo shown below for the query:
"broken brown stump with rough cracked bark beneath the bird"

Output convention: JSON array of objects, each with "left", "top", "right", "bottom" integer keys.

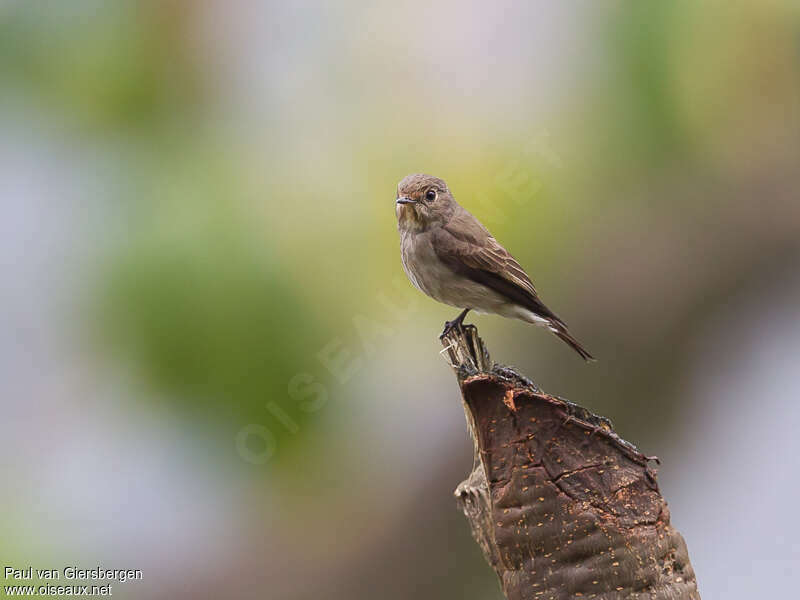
[{"left": 442, "top": 325, "right": 700, "bottom": 600}]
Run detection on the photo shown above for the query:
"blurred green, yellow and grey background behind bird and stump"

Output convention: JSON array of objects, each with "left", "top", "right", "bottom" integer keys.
[{"left": 0, "top": 0, "right": 800, "bottom": 600}]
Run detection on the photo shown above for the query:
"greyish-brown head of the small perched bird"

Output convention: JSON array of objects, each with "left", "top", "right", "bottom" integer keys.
[{"left": 395, "top": 173, "right": 456, "bottom": 231}]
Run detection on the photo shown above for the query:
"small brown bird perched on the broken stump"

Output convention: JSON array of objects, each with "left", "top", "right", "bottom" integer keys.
[{"left": 395, "top": 174, "right": 593, "bottom": 361}]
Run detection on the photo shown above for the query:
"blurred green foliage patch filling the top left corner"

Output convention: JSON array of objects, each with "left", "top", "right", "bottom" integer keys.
[{"left": 0, "top": 0, "right": 200, "bottom": 135}]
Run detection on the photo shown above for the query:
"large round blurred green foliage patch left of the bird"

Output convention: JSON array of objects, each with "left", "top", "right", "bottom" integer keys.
[{"left": 97, "top": 189, "right": 318, "bottom": 418}]
